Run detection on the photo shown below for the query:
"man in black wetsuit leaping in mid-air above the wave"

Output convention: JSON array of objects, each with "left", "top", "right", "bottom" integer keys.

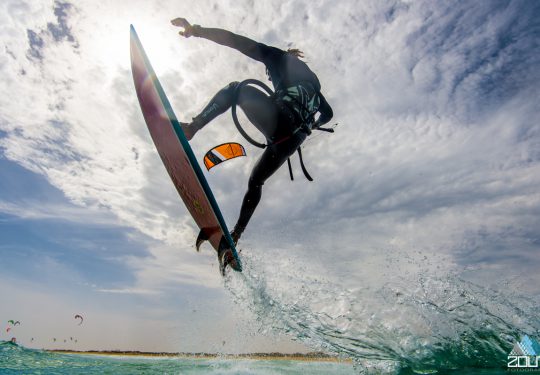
[{"left": 171, "top": 18, "right": 333, "bottom": 253}]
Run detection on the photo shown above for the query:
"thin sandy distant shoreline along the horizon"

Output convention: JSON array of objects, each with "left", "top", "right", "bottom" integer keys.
[{"left": 47, "top": 349, "right": 351, "bottom": 362}]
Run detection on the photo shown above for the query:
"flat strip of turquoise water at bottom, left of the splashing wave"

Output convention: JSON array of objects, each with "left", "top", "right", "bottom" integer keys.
[{"left": 0, "top": 343, "right": 354, "bottom": 375}]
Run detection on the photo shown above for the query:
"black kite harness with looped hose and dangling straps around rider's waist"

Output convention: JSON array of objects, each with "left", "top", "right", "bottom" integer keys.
[{"left": 231, "top": 79, "right": 334, "bottom": 181}]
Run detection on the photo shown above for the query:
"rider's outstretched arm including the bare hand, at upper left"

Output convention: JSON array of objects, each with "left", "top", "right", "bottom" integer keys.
[{"left": 171, "top": 17, "right": 266, "bottom": 61}]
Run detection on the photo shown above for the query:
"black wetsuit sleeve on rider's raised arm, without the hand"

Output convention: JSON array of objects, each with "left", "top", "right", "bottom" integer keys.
[{"left": 193, "top": 25, "right": 272, "bottom": 63}]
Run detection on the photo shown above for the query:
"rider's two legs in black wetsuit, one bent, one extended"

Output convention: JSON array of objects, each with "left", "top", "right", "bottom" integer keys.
[{"left": 186, "top": 82, "right": 307, "bottom": 242}]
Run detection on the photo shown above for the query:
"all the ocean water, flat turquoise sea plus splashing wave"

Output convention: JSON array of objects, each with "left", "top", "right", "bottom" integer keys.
[{"left": 0, "top": 252, "right": 540, "bottom": 375}]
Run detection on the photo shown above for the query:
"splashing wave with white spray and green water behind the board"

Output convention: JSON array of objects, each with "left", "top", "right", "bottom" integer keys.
[{"left": 226, "top": 248, "right": 540, "bottom": 373}]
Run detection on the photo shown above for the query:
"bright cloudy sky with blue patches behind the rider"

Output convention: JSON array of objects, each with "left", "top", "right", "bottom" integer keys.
[{"left": 0, "top": 0, "right": 540, "bottom": 352}]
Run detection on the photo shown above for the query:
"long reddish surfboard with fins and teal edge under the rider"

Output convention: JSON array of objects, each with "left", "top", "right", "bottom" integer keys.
[{"left": 130, "top": 25, "right": 242, "bottom": 274}]
